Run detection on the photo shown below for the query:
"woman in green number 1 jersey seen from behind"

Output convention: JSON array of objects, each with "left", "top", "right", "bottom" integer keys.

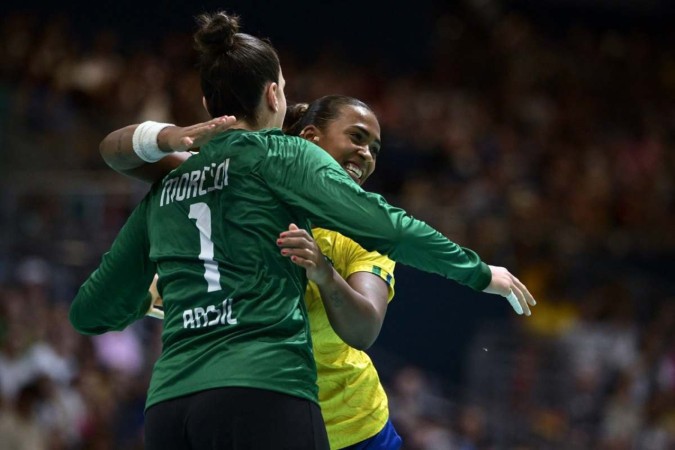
[{"left": 70, "top": 9, "right": 534, "bottom": 449}]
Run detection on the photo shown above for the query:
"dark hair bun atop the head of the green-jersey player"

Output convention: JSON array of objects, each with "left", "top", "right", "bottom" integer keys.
[{"left": 195, "top": 11, "right": 239, "bottom": 57}]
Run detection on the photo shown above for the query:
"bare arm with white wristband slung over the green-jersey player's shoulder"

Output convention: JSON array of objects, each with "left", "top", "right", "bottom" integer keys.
[{"left": 99, "top": 116, "right": 235, "bottom": 183}]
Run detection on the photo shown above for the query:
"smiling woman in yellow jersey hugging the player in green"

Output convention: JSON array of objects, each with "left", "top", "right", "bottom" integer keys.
[{"left": 100, "top": 95, "right": 401, "bottom": 450}]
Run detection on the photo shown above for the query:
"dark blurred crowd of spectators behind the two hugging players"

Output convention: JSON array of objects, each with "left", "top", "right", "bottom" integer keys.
[{"left": 0, "top": 0, "right": 675, "bottom": 450}]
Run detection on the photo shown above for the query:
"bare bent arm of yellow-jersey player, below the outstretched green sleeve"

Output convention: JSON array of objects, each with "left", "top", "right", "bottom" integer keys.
[{"left": 277, "top": 224, "right": 389, "bottom": 350}]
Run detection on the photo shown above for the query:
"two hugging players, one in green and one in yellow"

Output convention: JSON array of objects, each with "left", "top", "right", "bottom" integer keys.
[{"left": 70, "top": 12, "right": 535, "bottom": 450}]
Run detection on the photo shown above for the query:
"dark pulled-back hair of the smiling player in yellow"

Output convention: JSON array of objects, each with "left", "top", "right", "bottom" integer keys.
[{"left": 283, "top": 95, "right": 373, "bottom": 136}]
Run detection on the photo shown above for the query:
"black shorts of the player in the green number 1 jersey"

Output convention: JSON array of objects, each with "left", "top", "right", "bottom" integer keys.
[{"left": 145, "top": 387, "right": 328, "bottom": 450}]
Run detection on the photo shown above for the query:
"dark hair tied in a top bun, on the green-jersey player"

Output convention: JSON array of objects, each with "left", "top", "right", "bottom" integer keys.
[{"left": 194, "top": 11, "right": 281, "bottom": 126}]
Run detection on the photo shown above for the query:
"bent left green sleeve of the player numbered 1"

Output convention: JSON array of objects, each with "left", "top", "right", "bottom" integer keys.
[{"left": 69, "top": 197, "right": 156, "bottom": 334}]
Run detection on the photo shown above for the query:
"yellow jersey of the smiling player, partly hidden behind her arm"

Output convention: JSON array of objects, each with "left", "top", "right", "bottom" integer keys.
[{"left": 305, "top": 228, "right": 394, "bottom": 449}]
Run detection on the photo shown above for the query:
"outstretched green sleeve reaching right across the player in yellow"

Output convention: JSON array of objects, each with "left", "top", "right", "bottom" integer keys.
[{"left": 260, "top": 137, "right": 492, "bottom": 291}]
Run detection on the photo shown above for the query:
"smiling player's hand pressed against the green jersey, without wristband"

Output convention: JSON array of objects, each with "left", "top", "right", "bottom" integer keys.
[{"left": 277, "top": 223, "right": 333, "bottom": 285}]
